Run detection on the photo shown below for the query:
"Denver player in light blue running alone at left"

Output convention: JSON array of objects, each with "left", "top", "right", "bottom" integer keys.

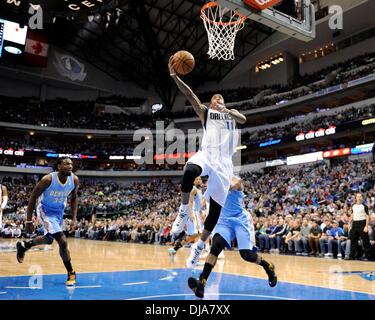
[{"left": 17, "top": 158, "right": 79, "bottom": 286}]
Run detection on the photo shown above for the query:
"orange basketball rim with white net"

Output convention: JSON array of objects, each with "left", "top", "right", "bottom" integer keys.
[{"left": 201, "top": 2, "right": 247, "bottom": 60}]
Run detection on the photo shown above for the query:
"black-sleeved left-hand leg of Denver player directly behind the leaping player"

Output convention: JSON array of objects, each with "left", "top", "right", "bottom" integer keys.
[{"left": 188, "top": 233, "right": 228, "bottom": 298}]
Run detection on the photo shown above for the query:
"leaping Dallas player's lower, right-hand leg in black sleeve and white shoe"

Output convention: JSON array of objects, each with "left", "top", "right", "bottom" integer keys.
[{"left": 186, "top": 198, "right": 221, "bottom": 268}]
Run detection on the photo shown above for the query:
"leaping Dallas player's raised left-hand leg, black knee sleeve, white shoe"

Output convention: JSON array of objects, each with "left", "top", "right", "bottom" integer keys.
[{"left": 172, "top": 163, "right": 202, "bottom": 234}]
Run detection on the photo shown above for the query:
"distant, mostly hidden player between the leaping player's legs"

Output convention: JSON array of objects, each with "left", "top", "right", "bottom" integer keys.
[{"left": 168, "top": 177, "right": 202, "bottom": 262}]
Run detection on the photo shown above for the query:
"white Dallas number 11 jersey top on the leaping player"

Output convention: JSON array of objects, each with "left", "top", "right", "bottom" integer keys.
[{"left": 202, "top": 107, "right": 238, "bottom": 159}]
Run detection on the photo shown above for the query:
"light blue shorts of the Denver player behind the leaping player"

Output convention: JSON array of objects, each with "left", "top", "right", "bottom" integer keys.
[{"left": 213, "top": 212, "right": 255, "bottom": 250}]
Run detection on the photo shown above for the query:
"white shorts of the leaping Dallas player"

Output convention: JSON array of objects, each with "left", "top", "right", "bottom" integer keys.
[{"left": 186, "top": 150, "right": 233, "bottom": 207}]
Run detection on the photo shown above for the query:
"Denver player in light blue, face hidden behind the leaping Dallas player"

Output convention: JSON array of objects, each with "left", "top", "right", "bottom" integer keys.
[{"left": 188, "top": 177, "right": 277, "bottom": 298}]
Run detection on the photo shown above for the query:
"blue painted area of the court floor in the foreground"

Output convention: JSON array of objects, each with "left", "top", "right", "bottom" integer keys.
[{"left": 0, "top": 269, "right": 375, "bottom": 300}]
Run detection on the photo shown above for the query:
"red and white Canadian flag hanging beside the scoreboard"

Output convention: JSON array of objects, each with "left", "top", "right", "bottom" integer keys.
[{"left": 24, "top": 30, "right": 49, "bottom": 68}]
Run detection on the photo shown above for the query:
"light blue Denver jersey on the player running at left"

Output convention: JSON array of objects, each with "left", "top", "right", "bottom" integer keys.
[{"left": 38, "top": 172, "right": 75, "bottom": 215}]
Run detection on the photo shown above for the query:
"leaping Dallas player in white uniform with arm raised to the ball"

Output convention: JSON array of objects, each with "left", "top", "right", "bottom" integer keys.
[{"left": 168, "top": 56, "right": 246, "bottom": 268}]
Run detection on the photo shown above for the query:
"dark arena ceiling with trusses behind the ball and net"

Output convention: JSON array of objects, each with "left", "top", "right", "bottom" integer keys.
[{"left": 0, "top": 0, "right": 274, "bottom": 107}]
